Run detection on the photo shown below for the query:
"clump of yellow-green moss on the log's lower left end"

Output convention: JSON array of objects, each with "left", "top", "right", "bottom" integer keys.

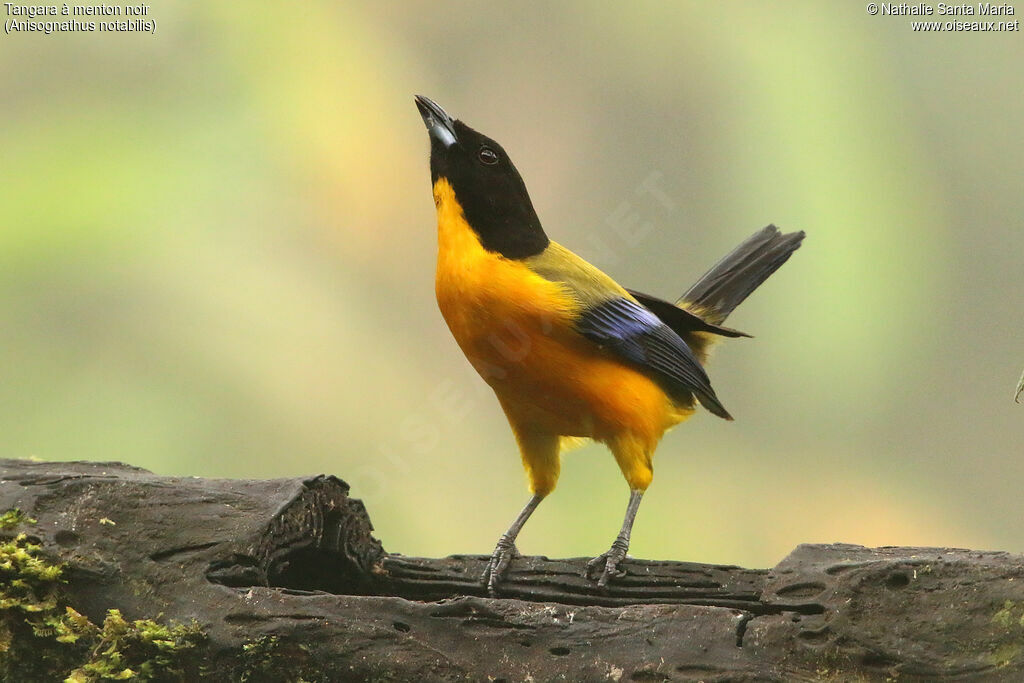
[{"left": 0, "top": 510, "right": 204, "bottom": 683}]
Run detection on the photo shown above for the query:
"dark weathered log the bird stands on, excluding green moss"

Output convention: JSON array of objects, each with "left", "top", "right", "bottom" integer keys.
[{"left": 0, "top": 461, "right": 1024, "bottom": 681}]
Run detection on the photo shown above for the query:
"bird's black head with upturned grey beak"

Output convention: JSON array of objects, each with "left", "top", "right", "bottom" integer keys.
[{"left": 416, "top": 95, "right": 549, "bottom": 258}]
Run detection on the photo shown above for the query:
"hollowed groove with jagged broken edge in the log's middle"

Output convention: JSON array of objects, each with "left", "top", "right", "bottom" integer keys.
[{"left": 199, "top": 476, "right": 786, "bottom": 614}]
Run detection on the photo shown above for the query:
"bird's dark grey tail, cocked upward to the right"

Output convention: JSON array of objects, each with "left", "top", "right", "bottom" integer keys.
[{"left": 678, "top": 225, "right": 804, "bottom": 325}]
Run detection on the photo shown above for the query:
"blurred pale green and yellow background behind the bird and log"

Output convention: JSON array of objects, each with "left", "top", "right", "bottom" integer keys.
[{"left": 0, "top": 0, "right": 1024, "bottom": 566}]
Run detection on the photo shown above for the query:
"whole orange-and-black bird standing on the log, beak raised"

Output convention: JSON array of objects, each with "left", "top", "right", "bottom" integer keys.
[{"left": 416, "top": 96, "right": 804, "bottom": 593}]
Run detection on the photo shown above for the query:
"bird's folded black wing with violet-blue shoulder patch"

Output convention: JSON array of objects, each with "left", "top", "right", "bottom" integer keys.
[{"left": 575, "top": 298, "right": 732, "bottom": 420}]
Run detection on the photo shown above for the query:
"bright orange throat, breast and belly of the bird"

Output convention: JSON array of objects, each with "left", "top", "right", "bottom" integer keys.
[{"left": 434, "top": 180, "right": 692, "bottom": 441}]
